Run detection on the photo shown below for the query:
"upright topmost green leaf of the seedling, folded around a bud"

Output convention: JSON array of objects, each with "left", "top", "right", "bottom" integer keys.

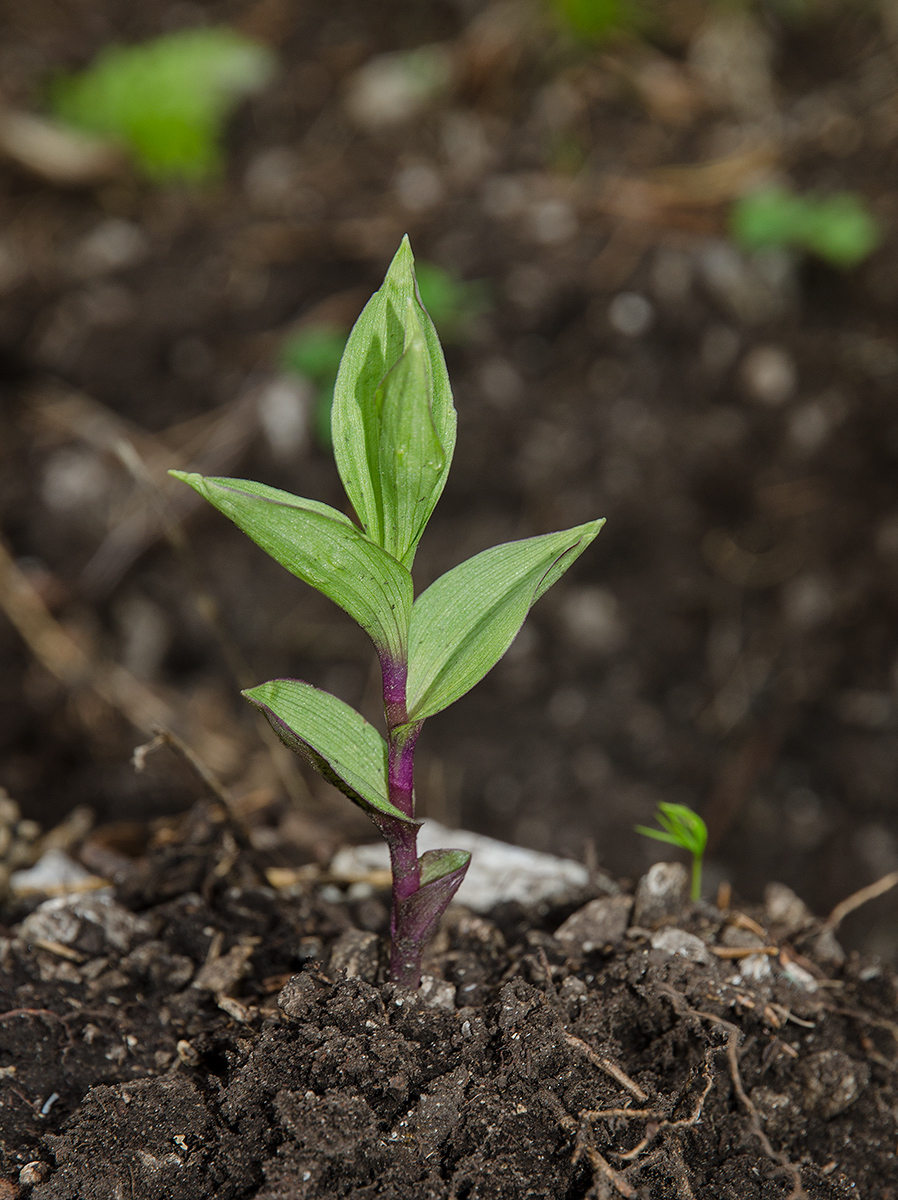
[{"left": 331, "top": 238, "right": 456, "bottom": 568}]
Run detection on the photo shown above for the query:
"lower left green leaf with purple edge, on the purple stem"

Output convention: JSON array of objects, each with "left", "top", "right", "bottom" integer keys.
[{"left": 244, "top": 679, "right": 418, "bottom": 828}]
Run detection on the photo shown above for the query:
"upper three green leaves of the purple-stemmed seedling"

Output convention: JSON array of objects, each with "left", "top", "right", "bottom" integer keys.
[{"left": 173, "top": 239, "right": 601, "bottom": 724}]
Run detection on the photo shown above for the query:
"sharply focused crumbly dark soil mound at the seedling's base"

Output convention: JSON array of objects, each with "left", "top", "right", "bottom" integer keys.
[{"left": 0, "top": 805, "right": 898, "bottom": 1200}]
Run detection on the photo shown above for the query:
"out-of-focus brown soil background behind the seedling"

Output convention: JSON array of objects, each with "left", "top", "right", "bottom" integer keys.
[{"left": 0, "top": 0, "right": 898, "bottom": 959}]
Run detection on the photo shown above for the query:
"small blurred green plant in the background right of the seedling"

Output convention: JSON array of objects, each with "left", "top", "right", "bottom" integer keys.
[{"left": 730, "top": 187, "right": 882, "bottom": 268}]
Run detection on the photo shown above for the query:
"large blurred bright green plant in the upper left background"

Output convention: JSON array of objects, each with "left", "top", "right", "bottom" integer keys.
[{"left": 49, "top": 28, "right": 275, "bottom": 184}]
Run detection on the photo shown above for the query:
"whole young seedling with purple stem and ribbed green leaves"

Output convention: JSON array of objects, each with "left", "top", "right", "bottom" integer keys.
[{"left": 172, "top": 239, "right": 603, "bottom": 988}]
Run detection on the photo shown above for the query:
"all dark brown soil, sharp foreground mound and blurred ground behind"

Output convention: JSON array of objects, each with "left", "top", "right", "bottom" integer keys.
[{"left": 0, "top": 0, "right": 898, "bottom": 1200}]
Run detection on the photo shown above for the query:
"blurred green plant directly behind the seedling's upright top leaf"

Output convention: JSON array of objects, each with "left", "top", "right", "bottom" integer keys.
[{"left": 280, "top": 263, "right": 490, "bottom": 446}]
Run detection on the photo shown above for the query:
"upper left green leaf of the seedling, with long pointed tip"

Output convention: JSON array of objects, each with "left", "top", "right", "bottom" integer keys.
[{"left": 170, "top": 470, "right": 413, "bottom": 661}]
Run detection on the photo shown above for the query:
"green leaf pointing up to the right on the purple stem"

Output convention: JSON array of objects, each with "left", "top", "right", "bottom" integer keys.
[{"left": 407, "top": 521, "right": 604, "bottom": 721}]
